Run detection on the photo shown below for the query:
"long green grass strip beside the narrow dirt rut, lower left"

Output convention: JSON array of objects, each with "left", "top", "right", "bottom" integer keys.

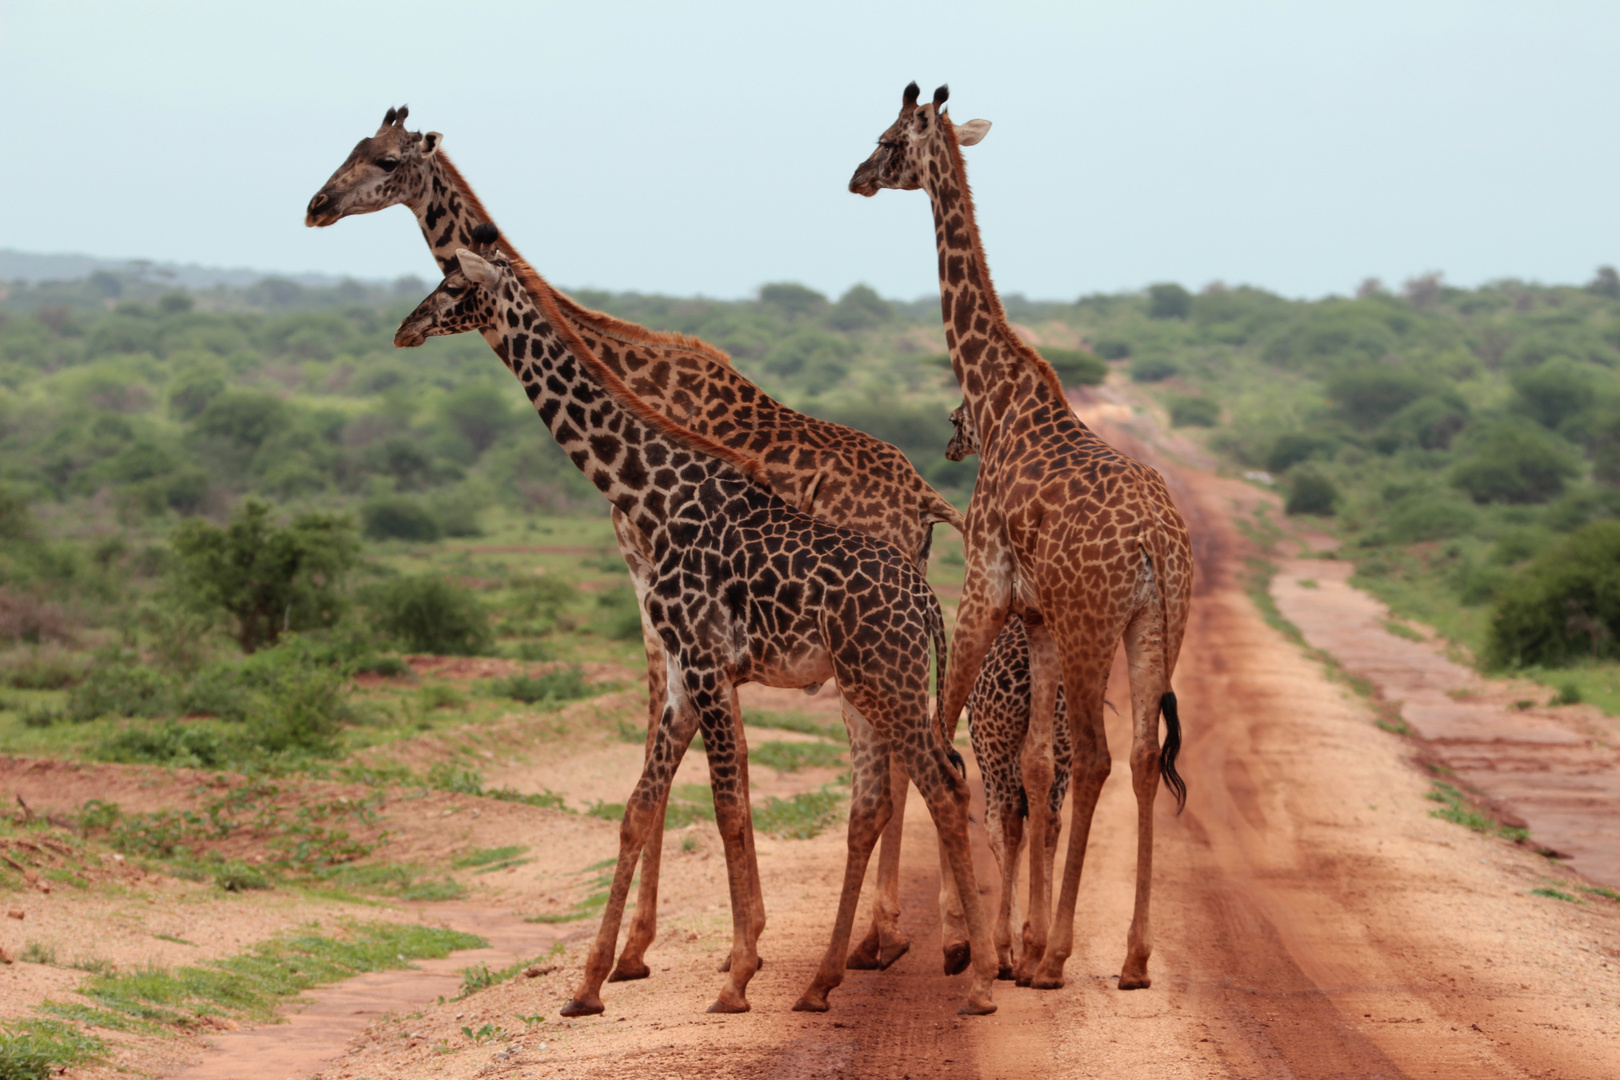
[{"left": 79, "top": 923, "right": 488, "bottom": 1027}]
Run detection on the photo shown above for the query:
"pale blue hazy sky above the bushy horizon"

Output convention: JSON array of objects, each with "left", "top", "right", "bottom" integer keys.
[{"left": 0, "top": 0, "right": 1620, "bottom": 300}]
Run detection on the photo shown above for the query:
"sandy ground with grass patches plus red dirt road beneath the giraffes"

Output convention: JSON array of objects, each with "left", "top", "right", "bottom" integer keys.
[{"left": 0, "top": 382, "right": 1620, "bottom": 1080}]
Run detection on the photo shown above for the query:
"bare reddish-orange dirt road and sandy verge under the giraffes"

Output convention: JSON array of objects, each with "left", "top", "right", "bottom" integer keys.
[{"left": 0, "top": 383, "right": 1620, "bottom": 1080}]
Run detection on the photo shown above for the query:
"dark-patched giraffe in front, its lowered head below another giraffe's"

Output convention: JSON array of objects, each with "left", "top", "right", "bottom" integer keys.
[{"left": 394, "top": 227, "right": 995, "bottom": 1015}]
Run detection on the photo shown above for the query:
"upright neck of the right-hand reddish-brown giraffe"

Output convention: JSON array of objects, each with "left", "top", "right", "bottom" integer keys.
[{"left": 925, "top": 123, "right": 1069, "bottom": 453}]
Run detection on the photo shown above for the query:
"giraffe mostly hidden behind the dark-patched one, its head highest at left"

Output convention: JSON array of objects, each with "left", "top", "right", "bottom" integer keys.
[{"left": 305, "top": 107, "right": 967, "bottom": 981}]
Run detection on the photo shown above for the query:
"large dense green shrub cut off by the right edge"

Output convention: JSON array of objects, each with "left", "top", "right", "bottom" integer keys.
[{"left": 1486, "top": 521, "right": 1620, "bottom": 667}]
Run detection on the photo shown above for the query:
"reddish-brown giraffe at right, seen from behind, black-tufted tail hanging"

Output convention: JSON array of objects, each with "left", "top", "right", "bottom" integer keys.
[{"left": 849, "top": 83, "right": 1192, "bottom": 989}]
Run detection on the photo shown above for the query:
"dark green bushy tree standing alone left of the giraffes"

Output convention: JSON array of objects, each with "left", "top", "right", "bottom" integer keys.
[{"left": 172, "top": 500, "right": 360, "bottom": 653}]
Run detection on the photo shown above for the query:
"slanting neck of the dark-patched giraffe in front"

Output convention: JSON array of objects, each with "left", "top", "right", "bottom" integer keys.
[{"left": 483, "top": 275, "right": 758, "bottom": 546}]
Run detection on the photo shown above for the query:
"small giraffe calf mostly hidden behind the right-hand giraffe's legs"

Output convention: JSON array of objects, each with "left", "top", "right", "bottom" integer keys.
[{"left": 944, "top": 405, "right": 1072, "bottom": 984}]
